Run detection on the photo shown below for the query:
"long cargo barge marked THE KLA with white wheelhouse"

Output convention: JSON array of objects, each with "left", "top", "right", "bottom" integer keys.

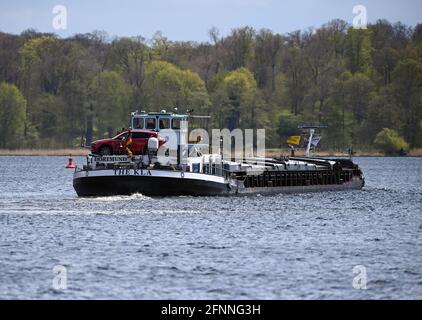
[{"left": 73, "top": 111, "right": 365, "bottom": 197}]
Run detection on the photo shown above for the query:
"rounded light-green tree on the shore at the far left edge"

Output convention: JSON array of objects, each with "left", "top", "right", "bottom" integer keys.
[{"left": 0, "top": 82, "right": 26, "bottom": 148}]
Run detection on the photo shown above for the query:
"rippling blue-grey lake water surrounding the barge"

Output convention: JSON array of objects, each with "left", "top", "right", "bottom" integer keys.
[{"left": 0, "top": 157, "right": 422, "bottom": 299}]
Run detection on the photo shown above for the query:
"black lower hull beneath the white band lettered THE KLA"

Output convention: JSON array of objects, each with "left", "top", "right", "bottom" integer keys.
[{"left": 73, "top": 176, "right": 230, "bottom": 197}]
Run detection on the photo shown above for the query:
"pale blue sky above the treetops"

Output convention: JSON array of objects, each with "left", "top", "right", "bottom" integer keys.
[{"left": 0, "top": 0, "right": 422, "bottom": 41}]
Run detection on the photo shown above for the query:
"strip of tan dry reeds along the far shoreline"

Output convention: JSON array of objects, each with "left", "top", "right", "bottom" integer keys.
[{"left": 0, "top": 148, "right": 422, "bottom": 158}]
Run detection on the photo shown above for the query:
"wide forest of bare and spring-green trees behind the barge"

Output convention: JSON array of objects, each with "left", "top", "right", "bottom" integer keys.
[{"left": 0, "top": 20, "right": 422, "bottom": 154}]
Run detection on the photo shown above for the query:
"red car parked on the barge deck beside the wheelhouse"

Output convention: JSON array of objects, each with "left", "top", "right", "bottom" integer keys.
[{"left": 91, "top": 130, "right": 166, "bottom": 156}]
